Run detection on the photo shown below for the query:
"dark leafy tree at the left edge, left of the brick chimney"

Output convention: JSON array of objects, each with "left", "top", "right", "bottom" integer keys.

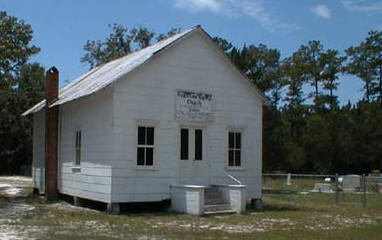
[{"left": 0, "top": 12, "right": 44, "bottom": 174}]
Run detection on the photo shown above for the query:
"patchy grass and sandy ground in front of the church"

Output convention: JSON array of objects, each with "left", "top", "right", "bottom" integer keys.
[{"left": 0, "top": 175, "right": 382, "bottom": 240}]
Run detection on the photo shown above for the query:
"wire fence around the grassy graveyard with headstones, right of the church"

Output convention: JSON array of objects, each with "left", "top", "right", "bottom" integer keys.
[{"left": 262, "top": 173, "right": 382, "bottom": 207}]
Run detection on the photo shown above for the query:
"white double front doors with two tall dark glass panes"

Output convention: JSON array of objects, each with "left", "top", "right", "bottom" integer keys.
[{"left": 179, "top": 126, "right": 210, "bottom": 185}]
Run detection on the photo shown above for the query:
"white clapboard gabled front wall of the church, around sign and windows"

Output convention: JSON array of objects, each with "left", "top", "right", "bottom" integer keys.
[{"left": 112, "top": 29, "right": 262, "bottom": 202}]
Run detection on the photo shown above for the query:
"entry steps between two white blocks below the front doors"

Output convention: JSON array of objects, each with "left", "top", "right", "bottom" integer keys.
[{"left": 203, "top": 187, "right": 236, "bottom": 215}]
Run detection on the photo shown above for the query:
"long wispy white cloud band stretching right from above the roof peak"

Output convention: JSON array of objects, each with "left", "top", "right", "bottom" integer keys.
[{"left": 171, "top": 0, "right": 299, "bottom": 32}]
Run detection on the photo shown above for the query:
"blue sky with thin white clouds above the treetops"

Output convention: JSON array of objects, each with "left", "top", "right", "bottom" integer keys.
[{"left": 0, "top": 0, "right": 382, "bottom": 103}]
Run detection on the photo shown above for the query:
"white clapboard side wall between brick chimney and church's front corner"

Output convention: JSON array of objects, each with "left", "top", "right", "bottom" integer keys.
[{"left": 59, "top": 89, "right": 114, "bottom": 202}]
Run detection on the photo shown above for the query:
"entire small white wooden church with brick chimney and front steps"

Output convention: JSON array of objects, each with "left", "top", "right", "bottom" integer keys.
[{"left": 24, "top": 26, "right": 267, "bottom": 215}]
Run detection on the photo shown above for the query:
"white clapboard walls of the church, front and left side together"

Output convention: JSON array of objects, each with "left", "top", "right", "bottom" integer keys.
[{"left": 33, "top": 30, "right": 263, "bottom": 202}]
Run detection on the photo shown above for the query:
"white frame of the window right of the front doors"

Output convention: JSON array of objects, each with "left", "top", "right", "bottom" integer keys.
[{"left": 226, "top": 128, "right": 244, "bottom": 167}]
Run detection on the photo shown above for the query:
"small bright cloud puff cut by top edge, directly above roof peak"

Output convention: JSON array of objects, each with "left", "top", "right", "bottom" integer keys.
[{"left": 172, "top": 0, "right": 221, "bottom": 12}]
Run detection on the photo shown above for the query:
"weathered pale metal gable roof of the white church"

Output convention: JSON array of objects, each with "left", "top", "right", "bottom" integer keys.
[{"left": 22, "top": 26, "right": 268, "bottom": 116}]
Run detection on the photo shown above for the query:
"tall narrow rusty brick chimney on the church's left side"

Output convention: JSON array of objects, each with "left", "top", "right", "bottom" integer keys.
[{"left": 45, "top": 67, "right": 59, "bottom": 202}]
